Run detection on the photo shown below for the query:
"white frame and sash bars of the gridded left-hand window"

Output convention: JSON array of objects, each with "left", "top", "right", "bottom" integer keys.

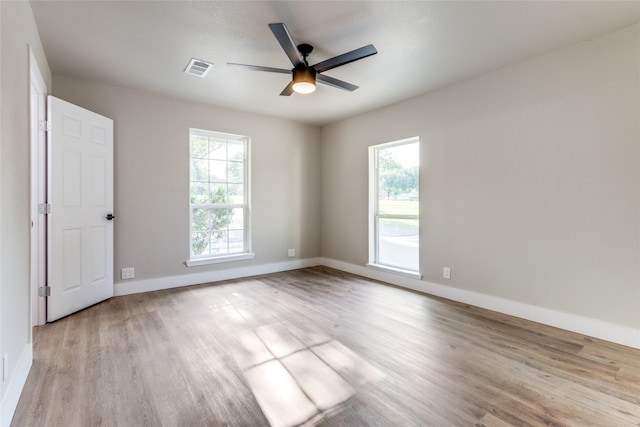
[{"left": 185, "top": 128, "right": 255, "bottom": 267}]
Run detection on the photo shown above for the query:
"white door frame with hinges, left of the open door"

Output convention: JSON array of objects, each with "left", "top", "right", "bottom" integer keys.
[{"left": 29, "top": 47, "right": 47, "bottom": 326}]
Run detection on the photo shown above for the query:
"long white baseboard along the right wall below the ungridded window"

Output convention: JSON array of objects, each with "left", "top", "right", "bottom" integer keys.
[{"left": 321, "top": 258, "right": 640, "bottom": 349}]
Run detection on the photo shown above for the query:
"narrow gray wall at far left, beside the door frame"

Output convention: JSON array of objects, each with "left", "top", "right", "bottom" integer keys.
[{"left": 0, "top": 1, "right": 51, "bottom": 423}]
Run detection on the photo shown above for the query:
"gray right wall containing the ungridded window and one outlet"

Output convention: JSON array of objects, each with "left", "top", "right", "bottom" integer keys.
[{"left": 322, "top": 25, "right": 640, "bottom": 331}]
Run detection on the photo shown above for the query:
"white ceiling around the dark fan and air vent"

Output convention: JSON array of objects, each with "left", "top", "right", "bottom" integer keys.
[{"left": 31, "top": 0, "right": 640, "bottom": 125}]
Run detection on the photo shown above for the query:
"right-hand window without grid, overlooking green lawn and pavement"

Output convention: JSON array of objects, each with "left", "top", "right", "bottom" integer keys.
[{"left": 368, "top": 137, "right": 420, "bottom": 277}]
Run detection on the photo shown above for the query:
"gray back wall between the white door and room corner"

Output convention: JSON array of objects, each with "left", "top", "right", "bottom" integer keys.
[{"left": 53, "top": 75, "right": 320, "bottom": 282}]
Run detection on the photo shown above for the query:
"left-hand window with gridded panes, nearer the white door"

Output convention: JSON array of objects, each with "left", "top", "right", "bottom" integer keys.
[{"left": 187, "top": 129, "right": 253, "bottom": 266}]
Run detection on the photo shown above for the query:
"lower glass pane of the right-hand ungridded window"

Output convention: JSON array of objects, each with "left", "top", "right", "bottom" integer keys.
[{"left": 377, "top": 218, "right": 419, "bottom": 271}]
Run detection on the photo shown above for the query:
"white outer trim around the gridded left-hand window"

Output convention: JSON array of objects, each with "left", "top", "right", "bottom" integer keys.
[{"left": 185, "top": 128, "right": 255, "bottom": 267}]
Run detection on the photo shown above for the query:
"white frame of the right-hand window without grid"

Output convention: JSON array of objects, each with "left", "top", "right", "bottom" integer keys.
[{"left": 366, "top": 136, "right": 422, "bottom": 279}]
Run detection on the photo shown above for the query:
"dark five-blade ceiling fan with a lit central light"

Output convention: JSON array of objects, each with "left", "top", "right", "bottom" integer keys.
[{"left": 227, "top": 23, "right": 378, "bottom": 96}]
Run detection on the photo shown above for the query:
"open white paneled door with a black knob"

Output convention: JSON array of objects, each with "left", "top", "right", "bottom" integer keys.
[{"left": 47, "top": 96, "right": 113, "bottom": 322}]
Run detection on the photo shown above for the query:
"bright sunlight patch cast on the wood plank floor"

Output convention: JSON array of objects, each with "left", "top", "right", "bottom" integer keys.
[{"left": 234, "top": 323, "right": 383, "bottom": 427}]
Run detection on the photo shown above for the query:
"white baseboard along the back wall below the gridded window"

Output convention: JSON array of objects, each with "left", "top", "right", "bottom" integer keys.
[{"left": 113, "top": 258, "right": 321, "bottom": 296}]
